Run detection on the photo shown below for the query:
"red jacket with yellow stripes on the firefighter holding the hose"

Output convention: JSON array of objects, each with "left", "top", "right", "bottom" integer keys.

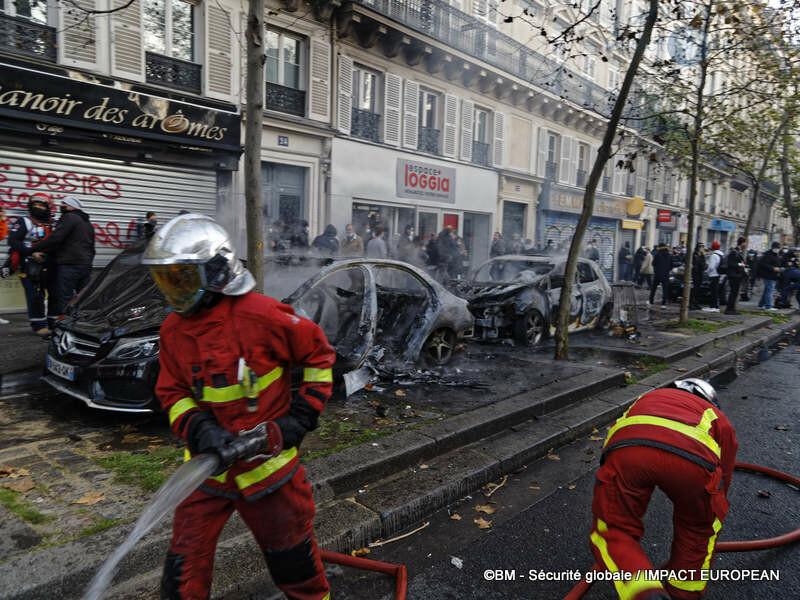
[{"left": 156, "top": 292, "right": 336, "bottom": 499}]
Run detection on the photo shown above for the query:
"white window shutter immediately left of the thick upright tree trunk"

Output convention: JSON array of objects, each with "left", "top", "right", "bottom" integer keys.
[{"left": 203, "top": 2, "right": 233, "bottom": 102}]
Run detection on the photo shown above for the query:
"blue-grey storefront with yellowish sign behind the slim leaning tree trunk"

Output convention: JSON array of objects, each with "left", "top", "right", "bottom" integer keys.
[{"left": 539, "top": 183, "right": 628, "bottom": 280}]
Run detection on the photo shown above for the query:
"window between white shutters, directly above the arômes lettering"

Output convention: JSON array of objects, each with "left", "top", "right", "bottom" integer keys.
[{"left": 144, "top": 0, "right": 195, "bottom": 62}]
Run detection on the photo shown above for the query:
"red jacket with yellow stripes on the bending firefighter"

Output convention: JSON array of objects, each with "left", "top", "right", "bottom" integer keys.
[{"left": 603, "top": 388, "right": 739, "bottom": 511}]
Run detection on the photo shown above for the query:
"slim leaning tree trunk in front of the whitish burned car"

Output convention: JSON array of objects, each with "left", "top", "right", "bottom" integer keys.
[{"left": 555, "top": 0, "right": 659, "bottom": 360}]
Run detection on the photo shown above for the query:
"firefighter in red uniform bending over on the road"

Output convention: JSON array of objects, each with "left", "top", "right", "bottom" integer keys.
[{"left": 590, "top": 379, "right": 738, "bottom": 600}]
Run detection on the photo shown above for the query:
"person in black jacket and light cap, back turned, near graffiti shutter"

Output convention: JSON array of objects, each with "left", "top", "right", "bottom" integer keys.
[{"left": 33, "top": 196, "right": 94, "bottom": 315}]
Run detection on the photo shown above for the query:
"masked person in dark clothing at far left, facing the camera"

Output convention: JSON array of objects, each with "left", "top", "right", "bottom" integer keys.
[{"left": 8, "top": 198, "right": 59, "bottom": 336}]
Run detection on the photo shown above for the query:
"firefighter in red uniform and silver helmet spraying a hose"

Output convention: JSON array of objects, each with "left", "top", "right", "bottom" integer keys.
[{"left": 142, "top": 214, "right": 335, "bottom": 600}]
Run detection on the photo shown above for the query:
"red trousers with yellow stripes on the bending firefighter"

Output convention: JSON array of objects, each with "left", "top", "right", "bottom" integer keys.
[{"left": 590, "top": 446, "right": 727, "bottom": 600}]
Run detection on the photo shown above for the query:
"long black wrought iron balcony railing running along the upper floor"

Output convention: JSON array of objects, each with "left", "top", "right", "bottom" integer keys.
[{"left": 354, "top": 0, "right": 611, "bottom": 112}]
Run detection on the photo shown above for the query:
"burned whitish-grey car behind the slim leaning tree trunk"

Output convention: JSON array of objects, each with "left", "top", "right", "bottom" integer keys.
[{"left": 452, "top": 255, "right": 614, "bottom": 345}]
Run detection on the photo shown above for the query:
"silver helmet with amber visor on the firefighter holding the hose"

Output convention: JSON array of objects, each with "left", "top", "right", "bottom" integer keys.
[{"left": 142, "top": 213, "right": 255, "bottom": 315}]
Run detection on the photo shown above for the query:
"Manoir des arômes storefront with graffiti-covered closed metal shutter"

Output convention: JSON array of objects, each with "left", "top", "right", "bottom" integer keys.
[{"left": 0, "top": 64, "right": 241, "bottom": 310}]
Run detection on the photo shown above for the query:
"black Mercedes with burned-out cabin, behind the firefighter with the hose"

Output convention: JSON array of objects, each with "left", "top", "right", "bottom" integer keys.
[{"left": 43, "top": 243, "right": 472, "bottom": 412}]
